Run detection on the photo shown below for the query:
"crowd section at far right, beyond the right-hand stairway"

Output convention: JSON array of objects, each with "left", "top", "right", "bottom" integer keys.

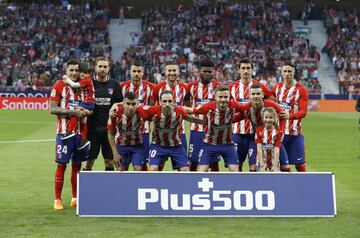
[{"left": 323, "top": 6, "right": 360, "bottom": 94}]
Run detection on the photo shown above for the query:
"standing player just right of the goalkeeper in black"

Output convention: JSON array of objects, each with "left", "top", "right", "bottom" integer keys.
[{"left": 120, "top": 61, "right": 154, "bottom": 170}]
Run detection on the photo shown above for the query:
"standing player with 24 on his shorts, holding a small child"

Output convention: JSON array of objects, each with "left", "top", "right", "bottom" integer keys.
[{"left": 50, "top": 61, "right": 88, "bottom": 210}]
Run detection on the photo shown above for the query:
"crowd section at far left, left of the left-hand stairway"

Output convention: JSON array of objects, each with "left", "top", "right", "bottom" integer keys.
[{"left": 0, "top": 2, "right": 111, "bottom": 91}]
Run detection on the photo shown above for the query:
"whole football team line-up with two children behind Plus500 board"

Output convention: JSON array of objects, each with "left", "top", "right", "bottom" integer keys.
[{"left": 50, "top": 57, "right": 308, "bottom": 209}]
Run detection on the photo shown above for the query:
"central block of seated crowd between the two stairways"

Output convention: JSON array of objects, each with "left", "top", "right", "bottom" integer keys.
[{"left": 119, "top": 1, "right": 320, "bottom": 89}]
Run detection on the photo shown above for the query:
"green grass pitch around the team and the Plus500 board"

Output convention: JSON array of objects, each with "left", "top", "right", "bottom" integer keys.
[{"left": 0, "top": 111, "right": 360, "bottom": 238}]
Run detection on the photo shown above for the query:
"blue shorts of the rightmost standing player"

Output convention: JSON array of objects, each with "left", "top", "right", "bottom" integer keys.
[{"left": 283, "top": 135, "right": 305, "bottom": 164}]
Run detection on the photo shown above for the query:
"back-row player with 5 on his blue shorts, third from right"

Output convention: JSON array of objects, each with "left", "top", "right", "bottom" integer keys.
[{"left": 187, "top": 60, "right": 219, "bottom": 171}]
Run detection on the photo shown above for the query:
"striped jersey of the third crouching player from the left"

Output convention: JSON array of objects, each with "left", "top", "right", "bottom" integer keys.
[{"left": 193, "top": 100, "right": 244, "bottom": 145}]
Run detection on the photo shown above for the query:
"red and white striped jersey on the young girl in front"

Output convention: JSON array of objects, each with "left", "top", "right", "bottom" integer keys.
[{"left": 255, "top": 125, "right": 284, "bottom": 168}]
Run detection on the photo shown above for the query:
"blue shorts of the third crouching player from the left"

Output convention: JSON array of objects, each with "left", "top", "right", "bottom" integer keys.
[{"left": 198, "top": 142, "right": 239, "bottom": 166}]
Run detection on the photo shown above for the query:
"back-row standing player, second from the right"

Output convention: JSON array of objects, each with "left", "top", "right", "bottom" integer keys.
[{"left": 229, "top": 58, "right": 271, "bottom": 171}]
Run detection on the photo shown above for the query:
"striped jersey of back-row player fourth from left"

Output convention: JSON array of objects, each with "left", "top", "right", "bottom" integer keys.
[{"left": 151, "top": 82, "right": 188, "bottom": 134}]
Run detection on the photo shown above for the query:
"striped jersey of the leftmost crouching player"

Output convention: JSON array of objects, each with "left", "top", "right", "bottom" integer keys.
[{"left": 107, "top": 105, "right": 144, "bottom": 145}]
